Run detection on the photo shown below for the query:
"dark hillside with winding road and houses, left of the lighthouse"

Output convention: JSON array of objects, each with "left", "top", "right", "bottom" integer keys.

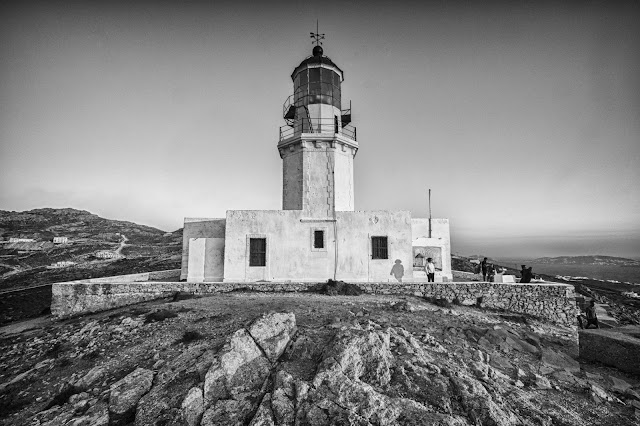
[{"left": 0, "top": 208, "right": 182, "bottom": 290}]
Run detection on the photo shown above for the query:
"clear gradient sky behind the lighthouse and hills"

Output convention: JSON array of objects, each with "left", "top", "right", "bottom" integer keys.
[{"left": 0, "top": 0, "right": 640, "bottom": 258}]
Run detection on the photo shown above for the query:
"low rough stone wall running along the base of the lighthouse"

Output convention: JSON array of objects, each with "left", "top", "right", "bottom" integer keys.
[{"left": 51, "top": 271, "right": 577, "bottom": 324}]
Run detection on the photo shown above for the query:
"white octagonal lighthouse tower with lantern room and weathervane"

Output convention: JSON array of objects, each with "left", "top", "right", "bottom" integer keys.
[{"left": 278, "top": 40, "right": 358, "bottom": 218}]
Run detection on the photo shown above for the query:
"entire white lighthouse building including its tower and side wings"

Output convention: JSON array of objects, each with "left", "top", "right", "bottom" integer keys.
[{"left": 181, "top": 46, "right": 452, "bottom": 282}]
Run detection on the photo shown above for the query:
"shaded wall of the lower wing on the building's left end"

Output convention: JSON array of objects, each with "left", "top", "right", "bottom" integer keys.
[{"left": 180, "top": 217, "right": 225, "bottom": 280}]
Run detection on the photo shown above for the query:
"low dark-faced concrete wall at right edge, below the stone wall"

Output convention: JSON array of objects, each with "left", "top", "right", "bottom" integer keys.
[{"left": 578, "top": 325, "right": 640, "bottom": 374}]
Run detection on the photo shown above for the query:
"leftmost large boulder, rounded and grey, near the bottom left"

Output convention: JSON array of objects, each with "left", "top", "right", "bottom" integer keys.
[{"left": 109, "top": 368, "right": 153, "bottom": 425}]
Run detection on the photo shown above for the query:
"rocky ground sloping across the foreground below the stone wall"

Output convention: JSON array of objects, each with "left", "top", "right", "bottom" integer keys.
[{"left": 0, "top": 293, "right": 640, "bottom": 426}]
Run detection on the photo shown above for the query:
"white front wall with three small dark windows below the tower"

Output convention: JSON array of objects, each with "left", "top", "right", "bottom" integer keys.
[{"left": 224, "top": 210, "right": 413, "bottom": 282}]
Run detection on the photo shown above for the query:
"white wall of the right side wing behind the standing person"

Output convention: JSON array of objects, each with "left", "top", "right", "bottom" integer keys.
[{"left": 411, "top": 218, "right": 453, "bottom": 281}]
